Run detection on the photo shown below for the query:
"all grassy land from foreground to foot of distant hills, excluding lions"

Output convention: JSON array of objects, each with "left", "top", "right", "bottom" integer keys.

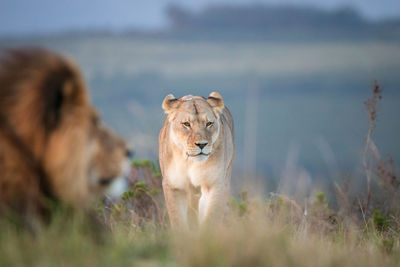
[{"left": 0, "top": 37, "right": 400, "bottom": 266}]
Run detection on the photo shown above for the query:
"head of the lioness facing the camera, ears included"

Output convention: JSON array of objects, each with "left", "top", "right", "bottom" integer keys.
[{"left": 162, "top": 92, "right": 224, "bottom": 161}]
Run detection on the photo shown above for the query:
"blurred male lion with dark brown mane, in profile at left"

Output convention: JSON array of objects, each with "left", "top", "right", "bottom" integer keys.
[{"left": 0, "top": 48, "right": 129, "bottom": 222}]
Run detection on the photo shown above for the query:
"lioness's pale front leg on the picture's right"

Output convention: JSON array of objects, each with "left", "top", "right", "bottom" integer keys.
[{"left": 199, "top": 186, "right": 227, "bottom": 225}]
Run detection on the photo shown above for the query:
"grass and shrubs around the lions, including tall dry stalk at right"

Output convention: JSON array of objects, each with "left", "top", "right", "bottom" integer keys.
[{"left": 0, "top": 74, "right": 400, "bottom": 267}]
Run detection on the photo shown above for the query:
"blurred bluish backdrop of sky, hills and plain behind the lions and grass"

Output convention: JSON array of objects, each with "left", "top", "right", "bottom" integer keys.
[{"left": 0, "top": 0, "right": 400, "bottom": 196}]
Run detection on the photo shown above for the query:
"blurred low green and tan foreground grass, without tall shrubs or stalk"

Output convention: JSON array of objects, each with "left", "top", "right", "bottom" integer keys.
[{"left": 0, "top": 179, "right": 400, "bottom": 266}]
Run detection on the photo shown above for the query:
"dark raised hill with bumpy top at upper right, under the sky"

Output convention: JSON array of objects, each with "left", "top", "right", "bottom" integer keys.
[{"left": 166, "top": 5, "right": 400, "bottom": 40}]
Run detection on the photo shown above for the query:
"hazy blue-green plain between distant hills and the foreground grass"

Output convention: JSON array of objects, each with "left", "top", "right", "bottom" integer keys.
[{"left": 0, "top": 36, "right": 400, "bottom": 178}]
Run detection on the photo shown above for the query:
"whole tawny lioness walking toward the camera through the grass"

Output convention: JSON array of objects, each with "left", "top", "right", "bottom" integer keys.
[{"left": 159, "top": 92, "right": 235, "bottom": 229}]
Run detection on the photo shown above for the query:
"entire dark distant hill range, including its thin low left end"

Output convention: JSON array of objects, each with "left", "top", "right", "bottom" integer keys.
[{"left": 5, "top": 4, "right": 400, "bottom": 42}]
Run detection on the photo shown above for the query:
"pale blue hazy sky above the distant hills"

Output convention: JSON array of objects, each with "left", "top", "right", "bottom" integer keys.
[{"left": 0, "top": 0, "right": 400, "bottom": 38}]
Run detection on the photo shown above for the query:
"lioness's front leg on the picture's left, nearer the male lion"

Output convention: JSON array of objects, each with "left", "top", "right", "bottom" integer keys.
[{"left": 163, "top": 181, "right": 189, "bottom": 229}]
